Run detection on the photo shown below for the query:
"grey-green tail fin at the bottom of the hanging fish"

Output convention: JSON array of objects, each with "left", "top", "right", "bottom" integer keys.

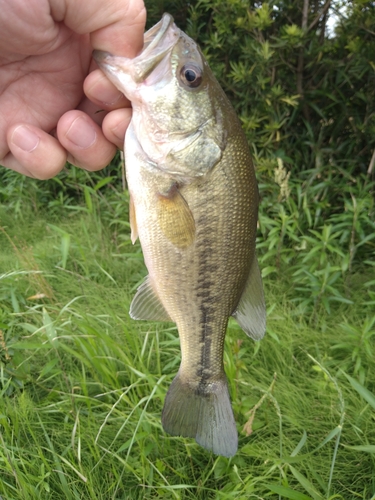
[{"left": 162, "top": 373, "right": 238, "bottom": 457}]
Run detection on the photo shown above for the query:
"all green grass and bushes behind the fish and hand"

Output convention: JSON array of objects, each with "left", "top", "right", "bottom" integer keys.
[{"left": 0, "top": 0, "right": 375, "bottom": 500}]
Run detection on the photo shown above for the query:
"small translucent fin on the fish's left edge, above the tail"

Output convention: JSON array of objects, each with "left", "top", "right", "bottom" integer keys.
[{"left": 129, "top": 276, "right": 172, "bottom": 321}]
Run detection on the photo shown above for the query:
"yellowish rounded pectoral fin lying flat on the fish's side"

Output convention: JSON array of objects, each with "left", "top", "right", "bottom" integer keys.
[{"left": 157, "top": 184, "right": 195, "bottom": 249}]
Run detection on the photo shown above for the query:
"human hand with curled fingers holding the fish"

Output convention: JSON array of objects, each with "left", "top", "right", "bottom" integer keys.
[{"left": 0, "top": 0, "right": 146, "bottom": 179}]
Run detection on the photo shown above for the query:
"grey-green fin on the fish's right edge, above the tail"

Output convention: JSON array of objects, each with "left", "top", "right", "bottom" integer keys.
[{"left": 232, "top": 256, "right": 266, "bottom": 340}]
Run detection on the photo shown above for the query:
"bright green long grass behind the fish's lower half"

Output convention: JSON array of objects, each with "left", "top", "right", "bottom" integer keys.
[{"left": 0, "top": 173, "right": 375, "bottom": 500}]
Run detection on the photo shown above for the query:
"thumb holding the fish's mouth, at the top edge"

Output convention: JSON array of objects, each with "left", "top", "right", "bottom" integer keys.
[{"left": 50, "top": 0, "right": 146, "bottom": 57}]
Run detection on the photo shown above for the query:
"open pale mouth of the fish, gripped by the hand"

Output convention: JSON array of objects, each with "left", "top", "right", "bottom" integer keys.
[{"left": 93, "top": 13, "right": 180, "bottom": 83}]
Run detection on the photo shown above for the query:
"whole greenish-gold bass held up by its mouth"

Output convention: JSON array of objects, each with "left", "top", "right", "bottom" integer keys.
[{"left": 93, "top": 14, "right": 266, "bottom": 457}]
